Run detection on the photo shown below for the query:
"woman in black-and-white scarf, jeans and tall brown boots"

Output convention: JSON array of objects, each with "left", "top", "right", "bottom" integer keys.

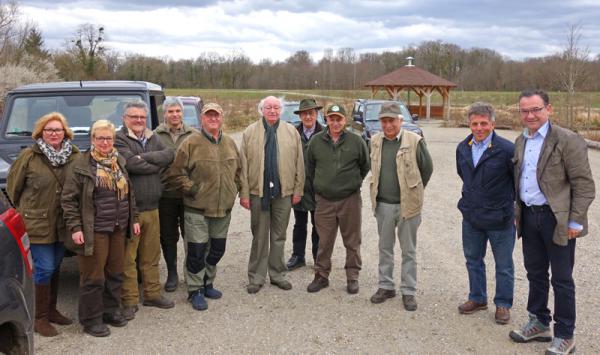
[{"left": 6, "top": 112, "right": 79, "bottom": 337}]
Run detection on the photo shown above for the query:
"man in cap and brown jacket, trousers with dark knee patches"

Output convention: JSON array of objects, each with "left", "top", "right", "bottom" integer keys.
[{"left": 169, "top": 103, "right": 241, "bottom": 310}]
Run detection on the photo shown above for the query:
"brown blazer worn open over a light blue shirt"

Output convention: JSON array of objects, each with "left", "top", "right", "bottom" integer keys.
[{"left": 513, "top": 125, "right": 596, "bottom": 246}]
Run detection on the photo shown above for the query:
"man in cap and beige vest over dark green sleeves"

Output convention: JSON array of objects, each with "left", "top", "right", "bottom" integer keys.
[{"left": 371, "top": 102, "right": 433, "bottom": 311}]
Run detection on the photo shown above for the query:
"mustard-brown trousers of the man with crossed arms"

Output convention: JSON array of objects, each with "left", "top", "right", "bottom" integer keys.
[{"left": 122, "top": 209, "right": 161, "bottom": 306}]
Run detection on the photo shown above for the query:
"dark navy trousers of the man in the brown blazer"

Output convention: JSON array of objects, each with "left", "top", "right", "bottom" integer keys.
[{"left": 521, "top": 206, "right": 575, "bottom": 339}]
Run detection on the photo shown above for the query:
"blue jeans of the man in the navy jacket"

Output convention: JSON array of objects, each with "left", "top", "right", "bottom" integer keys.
[{"left": 462, "top": 220, "right": 515, "bottom": 308}]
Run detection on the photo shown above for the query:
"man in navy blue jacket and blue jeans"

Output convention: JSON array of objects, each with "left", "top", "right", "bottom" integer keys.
[{"left": 456, "top": 102, "right": 515, "bottom": 324}]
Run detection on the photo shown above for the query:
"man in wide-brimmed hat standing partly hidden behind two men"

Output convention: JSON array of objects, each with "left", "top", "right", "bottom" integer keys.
[{"left": 287, "top": 99, "right": 323, "bottom": 270}]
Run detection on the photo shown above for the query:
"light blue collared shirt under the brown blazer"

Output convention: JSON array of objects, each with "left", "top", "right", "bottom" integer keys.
[{"left": 519, "top": 121, "right": 550, "bottom": 206}]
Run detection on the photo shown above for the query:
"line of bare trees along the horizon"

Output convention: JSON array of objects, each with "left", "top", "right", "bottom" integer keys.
[{"left": 0, "top": 2, "right": 600, "bottom": 97}]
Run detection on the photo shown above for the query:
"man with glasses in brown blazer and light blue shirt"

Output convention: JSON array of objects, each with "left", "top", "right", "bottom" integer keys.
[{"left": 509, "top": 90, "right": 596, "bottom": 354}]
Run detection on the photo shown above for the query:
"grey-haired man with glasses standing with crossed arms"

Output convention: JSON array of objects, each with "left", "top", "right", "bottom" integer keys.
[{"left": 115, "top": 100, "right": 174, "bottom": 320}]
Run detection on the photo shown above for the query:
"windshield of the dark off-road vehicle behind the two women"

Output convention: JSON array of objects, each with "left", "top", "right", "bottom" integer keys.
[{"left": 6, "top": 94, "right": 142, "bottom": 137}]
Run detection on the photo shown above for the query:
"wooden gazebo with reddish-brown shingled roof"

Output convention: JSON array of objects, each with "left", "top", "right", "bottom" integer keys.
[{"left": 365, "top": 57, "right": 457, "bottom": 119}]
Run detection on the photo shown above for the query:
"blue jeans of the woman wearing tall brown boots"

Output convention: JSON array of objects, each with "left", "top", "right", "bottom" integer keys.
[{"left": 31, "top": 242, "right": 65, "bottom": 285}]
